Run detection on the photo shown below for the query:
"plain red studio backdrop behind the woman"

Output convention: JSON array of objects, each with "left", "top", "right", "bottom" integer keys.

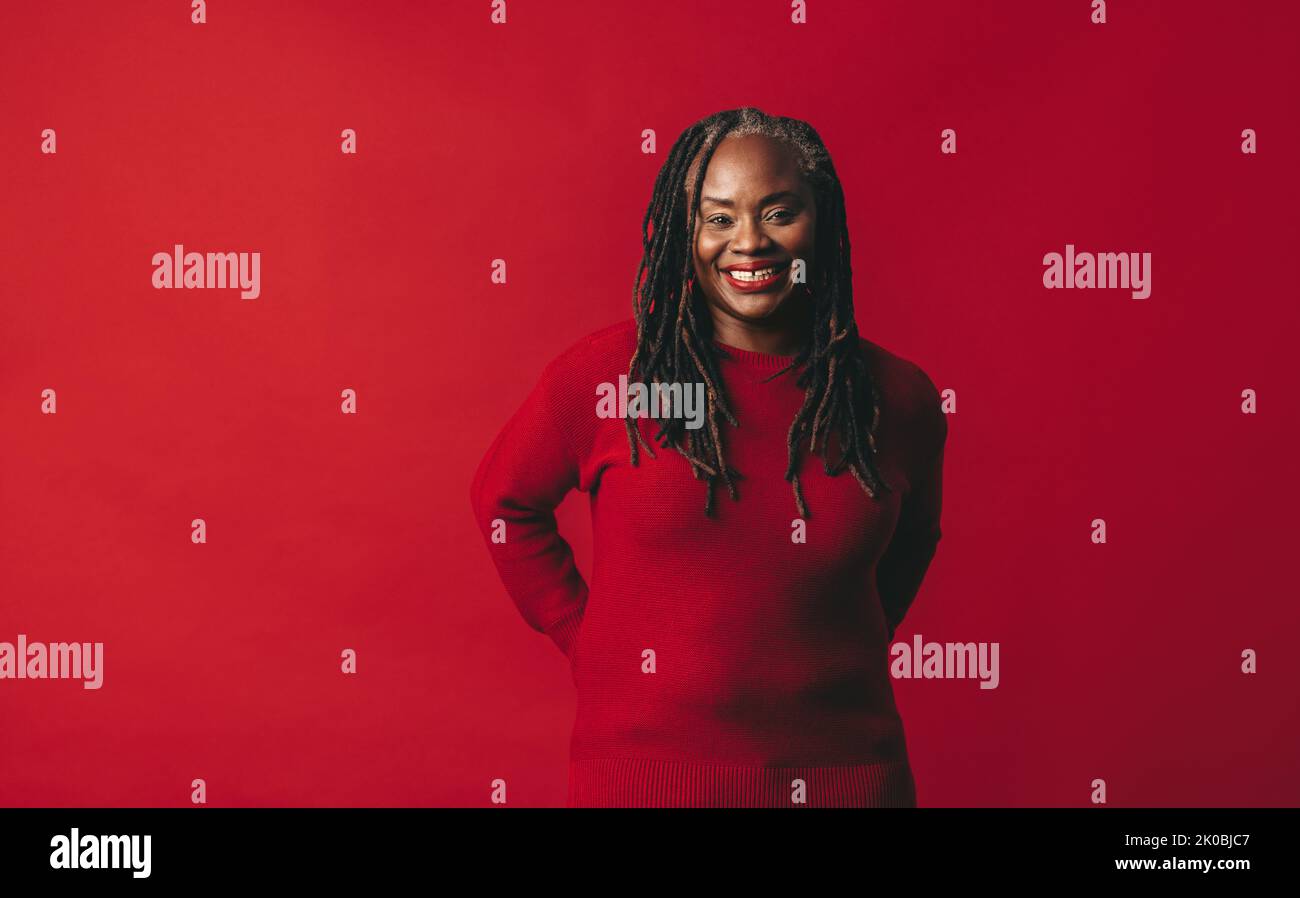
[{"left": 0, "top": 0, "right": 1300, "bottom": 806}]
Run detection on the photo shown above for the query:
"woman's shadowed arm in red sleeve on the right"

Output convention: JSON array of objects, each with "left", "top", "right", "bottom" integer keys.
[{"left": 876, "top": 369, "right": 948, "bottom": 639}]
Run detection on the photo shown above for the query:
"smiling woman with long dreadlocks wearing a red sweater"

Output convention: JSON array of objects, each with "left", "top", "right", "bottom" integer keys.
[{"left": 472, "top": 108, "right": 948, "bottom": 807}]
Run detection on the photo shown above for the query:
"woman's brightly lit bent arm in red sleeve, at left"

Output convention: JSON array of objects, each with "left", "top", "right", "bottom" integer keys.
[{"left": 469, "top": 368, "right": 588, "bottom": 656}]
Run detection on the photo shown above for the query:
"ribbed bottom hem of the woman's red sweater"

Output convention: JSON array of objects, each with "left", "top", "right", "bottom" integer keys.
[{"left": 568, "top": 758, "right": 917, "bottom": 807}]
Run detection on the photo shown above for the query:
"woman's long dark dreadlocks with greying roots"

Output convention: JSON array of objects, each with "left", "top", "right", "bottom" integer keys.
[{"left": 624, "top": 107, "right": 893, "bottom": 517}]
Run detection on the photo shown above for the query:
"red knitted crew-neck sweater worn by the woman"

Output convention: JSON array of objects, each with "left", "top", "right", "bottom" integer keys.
[{"left": 472, "top": 321, "right": 948, "bottom": 807}]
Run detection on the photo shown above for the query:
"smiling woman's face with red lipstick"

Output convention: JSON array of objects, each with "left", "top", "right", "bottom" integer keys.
[{"left": 688, "top": 134, "right": 816, "bottom": 329}]
